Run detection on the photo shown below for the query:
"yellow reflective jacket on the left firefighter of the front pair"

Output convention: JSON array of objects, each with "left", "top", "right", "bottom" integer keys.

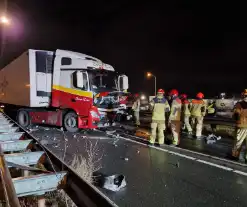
[{"left": 150, "top": 96, "right": 170, "bottom": 121}]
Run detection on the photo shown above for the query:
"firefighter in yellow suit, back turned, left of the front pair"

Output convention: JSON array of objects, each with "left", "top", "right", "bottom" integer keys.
[{"left": 149, "top": 89, "right": 170, "bottom": 145}]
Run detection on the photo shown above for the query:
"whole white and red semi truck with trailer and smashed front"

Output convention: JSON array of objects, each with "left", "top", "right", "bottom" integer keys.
[{"left": 0, "top": 49, "right": 128, "bottom": 132}]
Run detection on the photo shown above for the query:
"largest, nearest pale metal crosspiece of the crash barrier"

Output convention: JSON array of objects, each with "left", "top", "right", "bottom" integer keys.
[{"left": 12, "top": 172, "right": 67, "bottom": 197}]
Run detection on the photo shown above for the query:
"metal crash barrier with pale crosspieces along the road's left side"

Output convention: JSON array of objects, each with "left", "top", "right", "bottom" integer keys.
[{"left": 0, "top": 112, "right": 116, "bottom": 207}]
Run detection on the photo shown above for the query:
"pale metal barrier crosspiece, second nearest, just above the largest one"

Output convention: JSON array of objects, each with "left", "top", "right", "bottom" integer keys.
[{"left": 5, "top": 151, "right": 44, "bottom": 167}]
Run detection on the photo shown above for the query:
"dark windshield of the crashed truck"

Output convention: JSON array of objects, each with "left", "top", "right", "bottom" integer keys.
[{"left": 90, "top": 70, "right": 117, "bottom": 91}]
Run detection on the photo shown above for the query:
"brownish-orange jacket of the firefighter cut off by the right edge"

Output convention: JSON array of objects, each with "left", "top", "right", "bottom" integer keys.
[{"left": 234, "top": 101, "right": 247, "bottom": 128}]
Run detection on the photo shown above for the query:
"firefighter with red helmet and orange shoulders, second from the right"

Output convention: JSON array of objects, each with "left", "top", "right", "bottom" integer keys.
[{"left": 190, "top": 92, "right": 206, "bottom": 139}]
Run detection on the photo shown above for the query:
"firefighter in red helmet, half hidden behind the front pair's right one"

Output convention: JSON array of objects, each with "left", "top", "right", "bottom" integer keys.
[{"left": 180, "top": 94, "right": 192, "bottom": 135}]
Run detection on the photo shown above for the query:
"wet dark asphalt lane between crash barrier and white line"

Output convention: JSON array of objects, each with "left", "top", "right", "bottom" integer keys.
[{"left": 30, "top": 127, "right": 247, "bottom": 207}]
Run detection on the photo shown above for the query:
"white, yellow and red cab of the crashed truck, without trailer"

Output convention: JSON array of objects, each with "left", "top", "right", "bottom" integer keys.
[{"left": 34, "top": 50, "right": 128, "bottom": 131}]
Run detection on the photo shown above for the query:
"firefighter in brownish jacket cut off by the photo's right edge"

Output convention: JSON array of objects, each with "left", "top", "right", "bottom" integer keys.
[{"left": 232, "top": 89, "right": 247, "bottom": 162}]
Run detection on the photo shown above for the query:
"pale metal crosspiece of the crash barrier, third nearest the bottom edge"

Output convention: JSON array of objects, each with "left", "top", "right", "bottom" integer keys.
[{"left": 0, "top": 139, "right": 32, "bottom": 152}]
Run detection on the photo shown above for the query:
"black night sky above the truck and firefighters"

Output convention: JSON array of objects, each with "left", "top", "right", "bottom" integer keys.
[{"left": 0, "top": 0, "right": 247, "bottom": 96}]
